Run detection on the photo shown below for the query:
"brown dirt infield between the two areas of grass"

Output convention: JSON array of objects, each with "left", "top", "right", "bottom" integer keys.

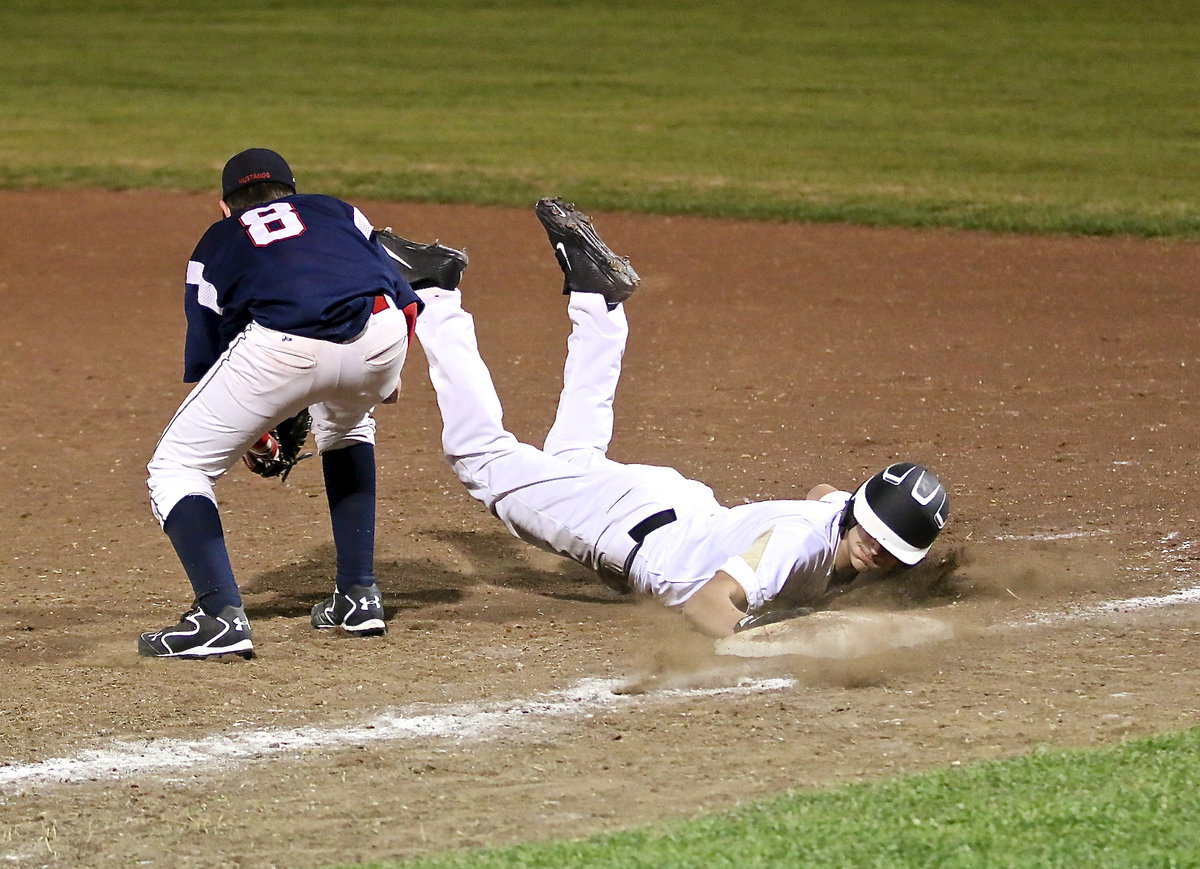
[{"left": 0, "top": 192, "right": 1200, "bottom": 867}]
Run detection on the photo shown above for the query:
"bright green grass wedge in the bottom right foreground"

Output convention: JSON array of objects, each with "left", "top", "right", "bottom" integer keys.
[{"left": 362, "top": 729, "right": 1200, "bottom": 869}]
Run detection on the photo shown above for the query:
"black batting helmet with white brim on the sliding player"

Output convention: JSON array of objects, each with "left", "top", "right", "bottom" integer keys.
[{"left": 851, "top": 462, "right": 950, "bottom": 564}]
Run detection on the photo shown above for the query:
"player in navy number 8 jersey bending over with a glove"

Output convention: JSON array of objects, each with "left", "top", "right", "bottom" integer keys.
[{"left": 138, "top": 148, "right": 420, "bottom": 658}]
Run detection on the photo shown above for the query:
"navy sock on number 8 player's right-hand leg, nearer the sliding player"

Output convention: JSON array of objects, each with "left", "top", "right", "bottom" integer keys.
[{"left": 320, "top": 444, "right": 376, "bottom": 594}]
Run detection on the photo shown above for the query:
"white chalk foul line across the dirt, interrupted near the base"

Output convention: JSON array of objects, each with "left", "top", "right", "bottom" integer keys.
[{"left": 0, "top": 586, "right": 1200, "bottom": 799}]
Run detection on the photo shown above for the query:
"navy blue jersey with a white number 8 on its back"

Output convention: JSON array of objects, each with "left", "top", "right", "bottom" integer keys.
[{"left": 177, "top": 193, "right": 420, "bottom": 383}]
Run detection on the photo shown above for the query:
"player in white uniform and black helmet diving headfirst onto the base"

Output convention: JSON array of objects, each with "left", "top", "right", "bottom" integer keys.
[{"left": 416, "top": 199, "right": 949, "bottom": 637}]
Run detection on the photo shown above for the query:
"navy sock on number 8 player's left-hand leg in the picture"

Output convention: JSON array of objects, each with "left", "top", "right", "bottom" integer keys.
[{"left": 163, "top": 495, "right": 241, "bottom": 616}]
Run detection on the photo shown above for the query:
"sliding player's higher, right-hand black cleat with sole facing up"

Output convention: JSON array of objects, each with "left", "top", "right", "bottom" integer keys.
[{"left": 534, "top": 199, "right": 642, "bottom": 306}]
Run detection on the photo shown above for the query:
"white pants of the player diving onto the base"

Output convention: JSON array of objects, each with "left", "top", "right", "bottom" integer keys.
[{"left": 416, "top": 289, "right": 707, "bottom": 575}]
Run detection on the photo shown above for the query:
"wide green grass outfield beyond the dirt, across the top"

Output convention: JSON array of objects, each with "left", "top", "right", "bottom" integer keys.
[{"left": 0, "top": 0, "right": 1200, "bottom": 238}]
